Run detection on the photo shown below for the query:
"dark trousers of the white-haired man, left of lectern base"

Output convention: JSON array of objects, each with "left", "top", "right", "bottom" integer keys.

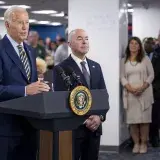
[{"left": 0, "top": 133, "right": 37, "bottom": 160}]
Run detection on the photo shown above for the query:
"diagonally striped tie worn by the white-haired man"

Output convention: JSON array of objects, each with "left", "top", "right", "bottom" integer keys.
[{"left": 17, "top": 45, "right": 31, "bottom": 80}]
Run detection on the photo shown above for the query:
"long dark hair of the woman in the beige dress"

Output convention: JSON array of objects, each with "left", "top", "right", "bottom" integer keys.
[{"left": 125, "top": 37, "right": 145, "bottom": 63}]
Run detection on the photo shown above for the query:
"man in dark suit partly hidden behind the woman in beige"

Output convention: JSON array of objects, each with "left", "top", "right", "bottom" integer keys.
[{"left": 144, "top": 38, "right": 160, "bottom": 147}]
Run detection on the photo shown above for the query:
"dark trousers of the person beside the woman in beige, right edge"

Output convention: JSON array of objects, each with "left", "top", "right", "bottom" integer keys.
[{"left": 149, "top": 100, "right": 160, "bottom": 142}]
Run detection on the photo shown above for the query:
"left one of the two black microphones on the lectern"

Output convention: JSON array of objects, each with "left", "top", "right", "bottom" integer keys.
[{"left": 57, "top": 66, "right": 72, "bottom": 90}]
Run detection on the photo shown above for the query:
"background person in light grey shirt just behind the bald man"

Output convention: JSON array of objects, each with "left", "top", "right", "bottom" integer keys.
[{"left": 54, "top": 38, "right": 68, "bottom": 65}]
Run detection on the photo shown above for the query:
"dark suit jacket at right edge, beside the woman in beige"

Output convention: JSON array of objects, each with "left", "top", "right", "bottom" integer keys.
[{"left": 152, "top": 50, "right": 160, "bottom": 100}]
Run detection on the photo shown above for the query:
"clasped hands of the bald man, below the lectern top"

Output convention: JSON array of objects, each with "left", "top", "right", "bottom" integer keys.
[{"left": 84, "top": 115, "right": 101, "bottom": 132}]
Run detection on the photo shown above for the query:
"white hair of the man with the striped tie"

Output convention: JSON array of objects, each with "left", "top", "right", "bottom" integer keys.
[{"left": 4, "top": 5, "right": 27, "bottom": 22}]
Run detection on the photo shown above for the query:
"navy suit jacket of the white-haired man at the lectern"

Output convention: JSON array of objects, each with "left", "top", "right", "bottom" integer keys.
[{"left": 0, "top": 36, "right": 37, "bottom": 136}]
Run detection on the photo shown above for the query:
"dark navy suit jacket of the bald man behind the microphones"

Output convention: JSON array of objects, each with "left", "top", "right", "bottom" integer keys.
[{"left": 53, "top": 56, "right": 106, "bottom": 137}]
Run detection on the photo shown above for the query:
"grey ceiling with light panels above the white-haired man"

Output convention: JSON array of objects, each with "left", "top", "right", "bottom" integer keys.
[{"left": 0, "top": 0, "right": 68, "bottom": 24}]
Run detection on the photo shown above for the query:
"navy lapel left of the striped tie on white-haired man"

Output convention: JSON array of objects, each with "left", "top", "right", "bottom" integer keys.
[{"left": 3, "top": 36, "right": 28, "bottom": 81}]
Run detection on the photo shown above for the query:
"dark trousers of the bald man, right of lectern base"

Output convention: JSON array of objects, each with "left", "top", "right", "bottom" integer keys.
[{"left": 74, "top": 132, "right": 100, "bottom": 160}]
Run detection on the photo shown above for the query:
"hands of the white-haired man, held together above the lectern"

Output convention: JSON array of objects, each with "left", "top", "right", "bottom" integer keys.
[{"left": 26, "top": 81, "right": 50, "bottom": 95}]
